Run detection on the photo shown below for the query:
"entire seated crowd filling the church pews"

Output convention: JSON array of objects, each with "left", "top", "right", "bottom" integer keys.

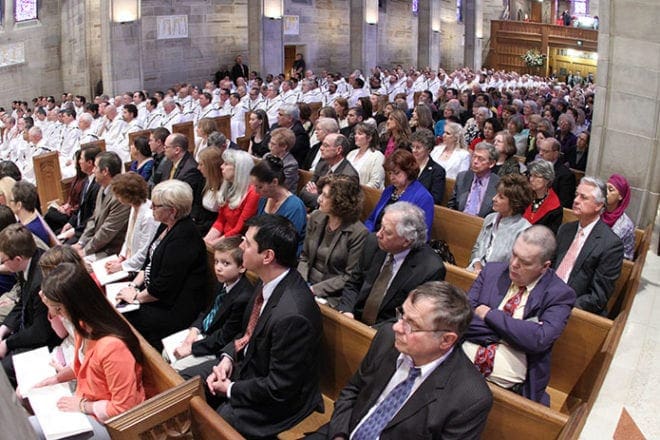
[{"left": 0, "top": 57, "right": 634, "bottom": 439}]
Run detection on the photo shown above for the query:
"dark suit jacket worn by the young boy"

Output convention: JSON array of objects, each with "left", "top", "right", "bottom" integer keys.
[{"left": 191, "top": 276, "right": 254, "bottom": 356}]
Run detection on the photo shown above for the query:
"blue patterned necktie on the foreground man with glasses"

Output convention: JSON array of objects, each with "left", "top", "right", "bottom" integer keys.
[{"left": 352, "top": 367, "right": 421, "bottom": 440}]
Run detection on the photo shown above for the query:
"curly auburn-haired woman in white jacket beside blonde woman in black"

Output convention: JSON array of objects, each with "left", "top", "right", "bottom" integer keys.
[{"left": 105, "top": 173, "right": 158, "bottom": 273}]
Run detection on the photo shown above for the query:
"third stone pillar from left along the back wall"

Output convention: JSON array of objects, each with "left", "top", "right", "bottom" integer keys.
[{"left": 349, "top": 0, "right": 378, "bottom": 74}]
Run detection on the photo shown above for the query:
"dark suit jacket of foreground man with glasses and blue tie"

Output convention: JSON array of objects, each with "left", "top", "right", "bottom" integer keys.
[{"left": 327, "top": 325, "right": 493, "bottom": 440}]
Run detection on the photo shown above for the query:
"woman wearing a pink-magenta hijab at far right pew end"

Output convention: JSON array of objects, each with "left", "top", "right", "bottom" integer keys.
[{"left": 601, "top": 174, "right": 635, "bottom": 260}]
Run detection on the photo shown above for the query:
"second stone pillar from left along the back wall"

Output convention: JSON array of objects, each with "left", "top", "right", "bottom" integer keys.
[{"left": 247, "top": 0, "right": 284, "bottom": 75}]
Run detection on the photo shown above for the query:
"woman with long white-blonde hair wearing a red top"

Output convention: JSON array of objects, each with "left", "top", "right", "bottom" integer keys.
[{"left": 204, "top": 150, "right": 259, "bottom": 246}]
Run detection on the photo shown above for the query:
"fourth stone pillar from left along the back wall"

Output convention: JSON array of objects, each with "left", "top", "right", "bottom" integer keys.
[{"left": 417, "top": 0, "right": 440, "bottom": 69}]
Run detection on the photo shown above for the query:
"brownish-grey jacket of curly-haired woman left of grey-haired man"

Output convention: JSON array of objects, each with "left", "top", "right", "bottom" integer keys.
[{"left": 298, "top": 211, "right": 369, "bottom": 297}]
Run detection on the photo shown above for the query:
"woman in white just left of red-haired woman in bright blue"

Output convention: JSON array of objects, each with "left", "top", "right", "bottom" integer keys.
[{"left": 346, "top": 122, "right": 385, "bottom": 189}]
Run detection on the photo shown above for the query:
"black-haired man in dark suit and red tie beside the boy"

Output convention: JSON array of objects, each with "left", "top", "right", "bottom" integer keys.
[{"left": 206, "top": 215, "right": 323, "bottom": 438}]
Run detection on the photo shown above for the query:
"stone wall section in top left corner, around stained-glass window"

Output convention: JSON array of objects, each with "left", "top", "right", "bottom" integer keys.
[{"left": 0, "top": 1, "right": 63, "bottom": 106}]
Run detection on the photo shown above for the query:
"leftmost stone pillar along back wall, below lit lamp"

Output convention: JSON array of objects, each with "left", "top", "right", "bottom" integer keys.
[{"left": 101, "top": 0, "right": 143, "bottom": 96}]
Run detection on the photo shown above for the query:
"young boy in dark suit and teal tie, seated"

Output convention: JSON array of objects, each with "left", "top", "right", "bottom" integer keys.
[{"left": 170, "top": 236, "right": 254, "bottom": 371}]
